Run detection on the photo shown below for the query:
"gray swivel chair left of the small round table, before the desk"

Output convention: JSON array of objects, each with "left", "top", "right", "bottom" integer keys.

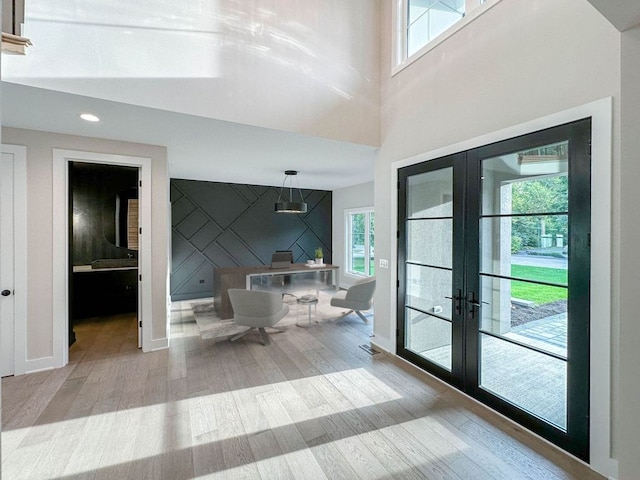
[{"left": 228, "top": 288, "right": 289, "bottom": 345}]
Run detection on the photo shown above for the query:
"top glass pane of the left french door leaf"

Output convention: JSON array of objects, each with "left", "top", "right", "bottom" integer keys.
[{"left": 407, "top": 168, "right": 453, "bottom": 218}]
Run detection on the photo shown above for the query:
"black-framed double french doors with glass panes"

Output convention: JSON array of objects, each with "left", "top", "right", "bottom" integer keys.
[{"left": 397, "top": 119, "right": 591, "bottom": 460}]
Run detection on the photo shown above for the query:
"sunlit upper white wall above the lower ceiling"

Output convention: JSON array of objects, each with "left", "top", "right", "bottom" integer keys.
[{"left": 3, "top": 0, "right": 380, "bottom": 145}]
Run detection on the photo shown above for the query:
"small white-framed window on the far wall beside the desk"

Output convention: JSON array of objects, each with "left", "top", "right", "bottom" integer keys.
[{"left": 345, "top": 208, "right": 375, "bottom": 277}]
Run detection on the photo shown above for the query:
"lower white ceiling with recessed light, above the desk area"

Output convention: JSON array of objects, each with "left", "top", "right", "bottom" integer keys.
[{"left": 1, "top": 82, "right": 377, "bottom": 190}]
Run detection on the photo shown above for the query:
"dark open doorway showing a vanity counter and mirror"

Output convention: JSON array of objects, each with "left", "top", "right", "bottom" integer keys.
[{"left": 68, "top": 161, "right": 141, "bottom": 348}]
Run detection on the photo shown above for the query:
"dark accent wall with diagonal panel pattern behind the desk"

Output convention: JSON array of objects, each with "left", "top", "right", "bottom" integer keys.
[{"left": 171, "top": 179, "right": 332, "bottom": 301}]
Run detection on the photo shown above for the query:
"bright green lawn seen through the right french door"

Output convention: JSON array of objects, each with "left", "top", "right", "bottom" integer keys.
[{"left": 511, "top": 265, "right": 567, "bottom": 305}]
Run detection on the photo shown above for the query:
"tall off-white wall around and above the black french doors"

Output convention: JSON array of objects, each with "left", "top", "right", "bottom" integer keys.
[{"left": 374, "top": 0, "right": 620, "bottom": 474}]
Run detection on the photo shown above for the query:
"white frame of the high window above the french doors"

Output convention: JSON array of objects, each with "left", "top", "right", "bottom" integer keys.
[{"left": 391, "top": 0, "right": 502, "bottom": 76}]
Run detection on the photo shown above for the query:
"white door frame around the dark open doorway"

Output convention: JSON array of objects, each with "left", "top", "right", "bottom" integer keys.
[{"left": 53, "top": 148, "right": 153, "bottom": 367}]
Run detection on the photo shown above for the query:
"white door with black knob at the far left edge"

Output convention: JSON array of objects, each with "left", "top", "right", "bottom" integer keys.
[{"left": 0, "top": 152, "right": 15, "bottom": 377}]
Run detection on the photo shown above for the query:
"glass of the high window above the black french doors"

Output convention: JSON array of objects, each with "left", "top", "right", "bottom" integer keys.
[{"left": 396, "top": 0, "right": 495, "bottom": 65}]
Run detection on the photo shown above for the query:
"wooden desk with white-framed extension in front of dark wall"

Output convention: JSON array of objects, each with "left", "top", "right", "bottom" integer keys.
[{"left": 213, "top": 263, "right": 339, "bottom": 319}]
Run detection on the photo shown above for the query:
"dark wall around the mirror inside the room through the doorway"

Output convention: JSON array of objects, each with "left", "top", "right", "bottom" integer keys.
[{"left": 69, "top": 162, "right": 138, "bottom": 265}]
